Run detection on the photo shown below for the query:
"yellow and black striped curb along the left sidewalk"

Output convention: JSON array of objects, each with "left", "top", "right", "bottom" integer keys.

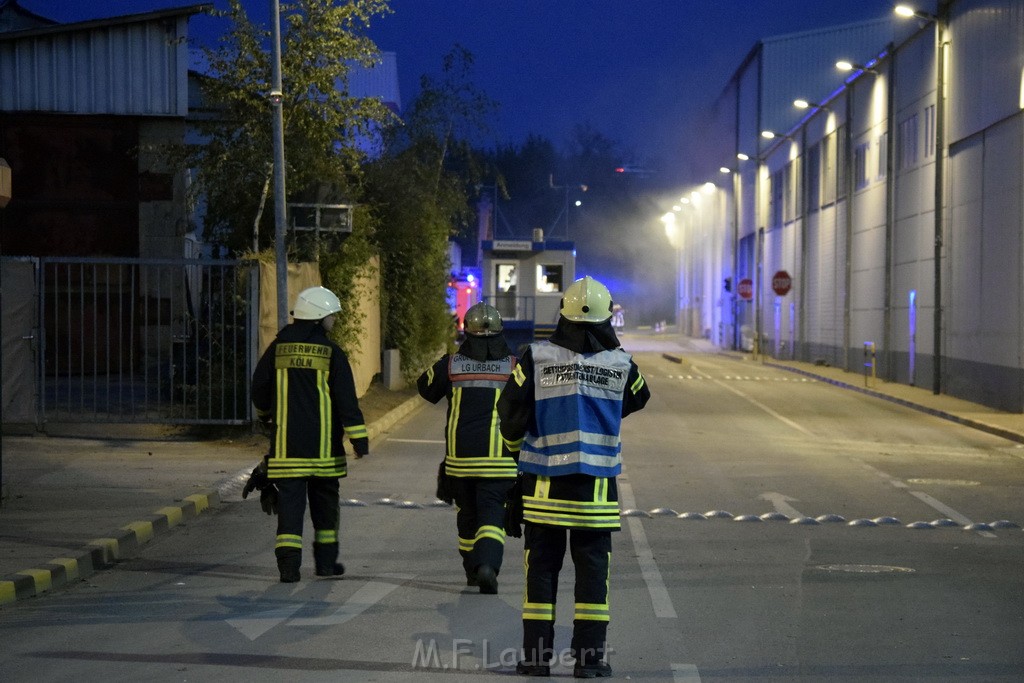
[{"left": 0, "top": 492, "right": 220, "bottom": 606}]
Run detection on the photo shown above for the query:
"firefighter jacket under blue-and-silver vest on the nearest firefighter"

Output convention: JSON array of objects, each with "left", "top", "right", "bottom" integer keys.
[{"left": 498, "top": 318, "right": 650, "bottom": 530}]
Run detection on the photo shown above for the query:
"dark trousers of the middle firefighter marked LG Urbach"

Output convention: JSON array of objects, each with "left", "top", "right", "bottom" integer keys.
[{"left": 449, "top": 477, "right": 515, "bottom": 577}]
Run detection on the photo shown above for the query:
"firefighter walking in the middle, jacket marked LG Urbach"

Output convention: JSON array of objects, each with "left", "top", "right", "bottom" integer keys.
[{"left": 417, "top": 303, "right": 516, "bottom": 594}]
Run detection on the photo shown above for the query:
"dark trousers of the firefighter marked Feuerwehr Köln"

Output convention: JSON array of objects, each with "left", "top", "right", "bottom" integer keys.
[{"left": 273, "top": 477, "right": 339, "bottom": 571}]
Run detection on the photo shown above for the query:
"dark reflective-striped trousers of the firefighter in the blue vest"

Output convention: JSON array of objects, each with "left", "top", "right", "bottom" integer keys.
[{"left": 522, "top": 522, "right": 611, "bottom": 666}]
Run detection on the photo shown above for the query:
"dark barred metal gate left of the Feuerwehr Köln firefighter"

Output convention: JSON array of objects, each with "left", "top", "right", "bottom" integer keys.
[{"left": 4, "top": 258, "right": 258, "bottom": 427}]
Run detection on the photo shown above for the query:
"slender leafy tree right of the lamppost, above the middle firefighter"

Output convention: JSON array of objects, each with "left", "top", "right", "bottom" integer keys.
[{"left": 366, "top": 46, "right": 494, "bottom": 379}]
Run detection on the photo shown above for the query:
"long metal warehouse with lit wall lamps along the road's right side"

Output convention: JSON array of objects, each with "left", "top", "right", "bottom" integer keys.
[{"left": 703, "top": 0, "right": 1024, "bottom": 411}]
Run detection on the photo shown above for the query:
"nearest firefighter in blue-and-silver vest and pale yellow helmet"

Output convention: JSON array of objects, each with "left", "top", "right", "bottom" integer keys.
[{"left": 498, "top": 276, "right": 650, "bottom": 678}]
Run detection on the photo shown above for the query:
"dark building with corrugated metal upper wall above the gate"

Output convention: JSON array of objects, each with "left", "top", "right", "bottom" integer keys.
[{"left": 0, "top": 0, "right": 212, "bottom": 257}]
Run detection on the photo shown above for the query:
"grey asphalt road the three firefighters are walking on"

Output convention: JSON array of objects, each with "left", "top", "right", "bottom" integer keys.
[{"left": 0, "top": 352, "right": 1024, "bottom": 683}]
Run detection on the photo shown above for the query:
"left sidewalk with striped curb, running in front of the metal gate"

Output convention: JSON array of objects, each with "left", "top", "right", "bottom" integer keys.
[{"left": 0, "top": 396, "right": 426, "bottom": 608}]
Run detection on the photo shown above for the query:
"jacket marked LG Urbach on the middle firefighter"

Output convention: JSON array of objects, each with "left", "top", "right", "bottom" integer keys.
[{"left": 417, "top": 337, "right": 516, "bottom": 479}]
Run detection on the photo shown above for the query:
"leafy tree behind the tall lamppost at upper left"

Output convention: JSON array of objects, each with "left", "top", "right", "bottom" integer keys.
[{"left": 186, "top": 0, "right": 392, "bottom": 251}]
